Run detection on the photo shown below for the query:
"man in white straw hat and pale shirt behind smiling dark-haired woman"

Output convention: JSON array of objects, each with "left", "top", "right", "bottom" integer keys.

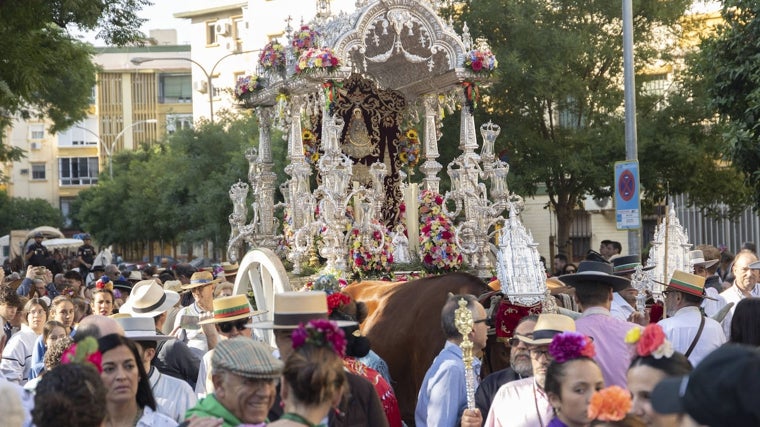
[{"left": 116, "top": 317, "right": 198, "bottom": 423}]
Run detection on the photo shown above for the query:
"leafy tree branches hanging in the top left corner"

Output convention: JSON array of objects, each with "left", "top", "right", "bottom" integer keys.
[{"left": 0, "top": 0, "right": 150, "bottom": 161}]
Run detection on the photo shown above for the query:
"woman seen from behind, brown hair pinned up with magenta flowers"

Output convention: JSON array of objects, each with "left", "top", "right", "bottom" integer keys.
[{"left": 270, "top": 320, "right": 347, "bottom": 427}]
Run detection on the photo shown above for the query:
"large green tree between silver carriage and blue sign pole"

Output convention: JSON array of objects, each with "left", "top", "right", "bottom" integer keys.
[{"left": 459, "top": 0, "right": 732, "bottom": 253}]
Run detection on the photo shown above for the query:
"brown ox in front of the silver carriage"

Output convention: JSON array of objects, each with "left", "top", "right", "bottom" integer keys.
[{"left": 345, "top": 273, "right": 509, "bottom": 425}]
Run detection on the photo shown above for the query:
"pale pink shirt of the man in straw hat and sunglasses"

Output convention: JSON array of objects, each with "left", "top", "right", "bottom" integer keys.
[{"left": 485, "top": 377, "right": 554, "bottom": 427}]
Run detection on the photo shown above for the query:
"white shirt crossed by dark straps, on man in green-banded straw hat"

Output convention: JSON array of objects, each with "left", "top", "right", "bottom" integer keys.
[{"left": 657, "top": 306, "right": 726, "bottom": 366}]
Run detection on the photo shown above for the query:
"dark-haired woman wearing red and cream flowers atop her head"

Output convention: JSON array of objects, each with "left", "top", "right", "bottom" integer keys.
[{"left": 625, "top": 323, "right": 692, "bottom": 427}]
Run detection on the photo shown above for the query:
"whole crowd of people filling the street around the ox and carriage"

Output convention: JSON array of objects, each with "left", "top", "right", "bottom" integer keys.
[{"left": 0, "top": 234, "right": 760, "bottom": 427}]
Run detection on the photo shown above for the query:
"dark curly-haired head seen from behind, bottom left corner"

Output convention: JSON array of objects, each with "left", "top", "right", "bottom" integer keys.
[{"left": 32, "top": 363, "right": 106, "bottom": 427}]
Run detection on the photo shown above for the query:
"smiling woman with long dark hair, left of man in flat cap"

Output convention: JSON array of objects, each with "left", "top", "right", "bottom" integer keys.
[{"left": 98, "top": 334, "right": 177, "bottom": 427}]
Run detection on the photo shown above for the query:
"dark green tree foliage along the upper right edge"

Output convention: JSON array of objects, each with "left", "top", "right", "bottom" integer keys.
[{"left": 694, "top": 0, "right": 760, "bottom": 209}]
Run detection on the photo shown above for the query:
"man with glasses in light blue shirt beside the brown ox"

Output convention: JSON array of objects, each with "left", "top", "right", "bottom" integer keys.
[{"left": 414, "top": 295, "right": 488, "bottom": 427}]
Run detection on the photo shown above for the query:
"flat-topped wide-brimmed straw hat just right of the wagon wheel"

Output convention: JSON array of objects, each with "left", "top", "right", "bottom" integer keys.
[{"left": 250, "top": 291, "right": 358, "bottom": 329}]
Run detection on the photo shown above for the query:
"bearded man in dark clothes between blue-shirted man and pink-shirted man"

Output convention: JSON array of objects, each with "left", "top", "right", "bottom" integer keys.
[{"left": 475, "top": 314, "right": 538, "bottom": 417}]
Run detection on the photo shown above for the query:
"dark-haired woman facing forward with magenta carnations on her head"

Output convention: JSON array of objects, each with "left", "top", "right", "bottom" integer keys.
[{"left": 544, "top": 332, "right": 604, "bottom": 427}]
